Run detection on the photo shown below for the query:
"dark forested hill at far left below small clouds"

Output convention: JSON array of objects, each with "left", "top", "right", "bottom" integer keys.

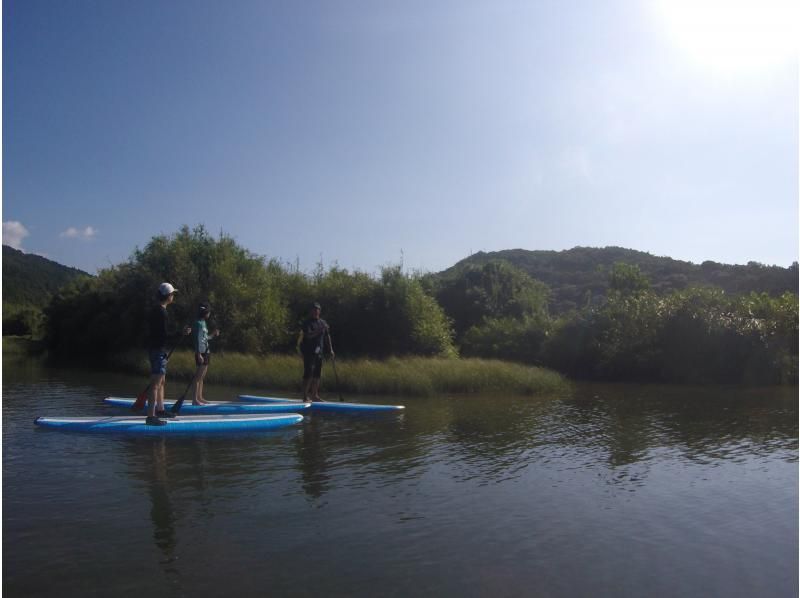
[{"left": 3, "top": 245, "right": 89, "bottom": 308}]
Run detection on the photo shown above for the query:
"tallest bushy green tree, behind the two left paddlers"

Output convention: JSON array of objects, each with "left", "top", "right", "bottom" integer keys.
[{"left": 46, "top": 226, "right": 288, "bottom": 359}]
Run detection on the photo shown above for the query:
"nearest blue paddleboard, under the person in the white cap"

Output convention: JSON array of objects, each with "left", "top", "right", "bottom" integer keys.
[{"left": 33, "top": 413, "right": 303, "bottom": 435}]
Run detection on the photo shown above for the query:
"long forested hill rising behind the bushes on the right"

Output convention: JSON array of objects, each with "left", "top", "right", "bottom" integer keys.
[{"left": 435, "top": 247, "right": 798, "bottom": 313}]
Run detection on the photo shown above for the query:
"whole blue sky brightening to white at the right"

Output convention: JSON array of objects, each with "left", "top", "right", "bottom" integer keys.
[{"left": 2, "top": 0, "right": 800, "bottom": 273}]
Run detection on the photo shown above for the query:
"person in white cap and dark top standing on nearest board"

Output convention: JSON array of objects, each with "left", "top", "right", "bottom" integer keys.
[{"left": 145, "top": 282, "right": 192, "bottom": 426}]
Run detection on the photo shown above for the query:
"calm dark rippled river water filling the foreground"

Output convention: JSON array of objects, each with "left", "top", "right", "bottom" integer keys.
[{"left": 2, "top": 363, "right": 798, "bottom": 598}]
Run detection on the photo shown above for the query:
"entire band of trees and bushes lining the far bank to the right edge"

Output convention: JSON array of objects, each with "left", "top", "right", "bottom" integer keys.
[{"left": 45, "top": 227, "right": 798, "bottom": 384}]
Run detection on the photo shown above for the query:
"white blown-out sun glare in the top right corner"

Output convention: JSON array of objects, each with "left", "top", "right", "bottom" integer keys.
[{"left": 657, "top": 0, "right": 800, "bottom": 72}]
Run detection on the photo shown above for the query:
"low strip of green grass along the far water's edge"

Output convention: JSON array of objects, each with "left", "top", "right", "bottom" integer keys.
[{"left": 3, "top": 337, "right": 569, "bottom": 396}]
